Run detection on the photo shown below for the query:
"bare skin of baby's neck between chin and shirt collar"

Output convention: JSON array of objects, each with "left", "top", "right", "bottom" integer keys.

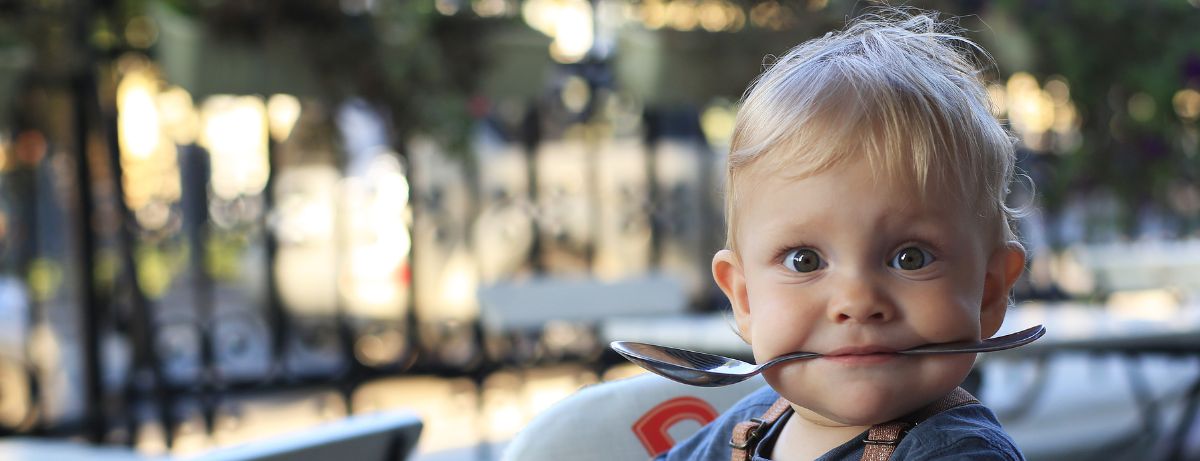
[{"left": 770, "top": 405, "right": 871, "bottom": 461}]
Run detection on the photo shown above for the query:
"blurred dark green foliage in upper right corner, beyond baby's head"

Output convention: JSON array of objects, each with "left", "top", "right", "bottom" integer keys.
[{"left": 991, "top": 0, "right": 1200, "bottom": 224}]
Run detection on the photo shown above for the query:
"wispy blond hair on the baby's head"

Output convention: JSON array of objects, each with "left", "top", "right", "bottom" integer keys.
[{"left": 725, "top": 10, "right": 1018, "bottom": 250}]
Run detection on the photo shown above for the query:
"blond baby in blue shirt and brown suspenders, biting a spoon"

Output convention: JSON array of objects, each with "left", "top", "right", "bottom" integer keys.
[{"left": 659, "top": 11, "right": 1025, "bottom": 460}]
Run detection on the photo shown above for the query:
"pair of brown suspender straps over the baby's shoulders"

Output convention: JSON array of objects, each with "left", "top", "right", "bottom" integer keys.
[{"left": 730, "top": 388, "right": 979, "bottom": 461}]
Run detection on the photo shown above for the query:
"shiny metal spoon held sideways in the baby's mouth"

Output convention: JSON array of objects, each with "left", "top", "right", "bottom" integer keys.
[{"left": 610, "top": 325, "right": 1046, "bottom": 388}]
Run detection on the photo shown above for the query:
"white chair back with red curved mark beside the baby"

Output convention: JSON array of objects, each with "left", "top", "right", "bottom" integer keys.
[{"left": 502, "top": 373, "right": 766, "bottom": 461}]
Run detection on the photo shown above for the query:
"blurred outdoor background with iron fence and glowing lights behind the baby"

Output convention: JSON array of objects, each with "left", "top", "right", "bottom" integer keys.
[{"left": 0, "top": 0, "right": 1200, "bottom": 460}]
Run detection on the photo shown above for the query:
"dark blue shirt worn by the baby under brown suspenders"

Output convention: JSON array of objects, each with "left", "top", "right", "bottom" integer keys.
[{"left": 656, "top": 387, "right": 1025, "bottom": 461}]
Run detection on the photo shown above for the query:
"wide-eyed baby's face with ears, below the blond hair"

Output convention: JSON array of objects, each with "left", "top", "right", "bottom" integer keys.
[{"left": 713, "top": 156, "right": 1024, "bottom": 426}]
